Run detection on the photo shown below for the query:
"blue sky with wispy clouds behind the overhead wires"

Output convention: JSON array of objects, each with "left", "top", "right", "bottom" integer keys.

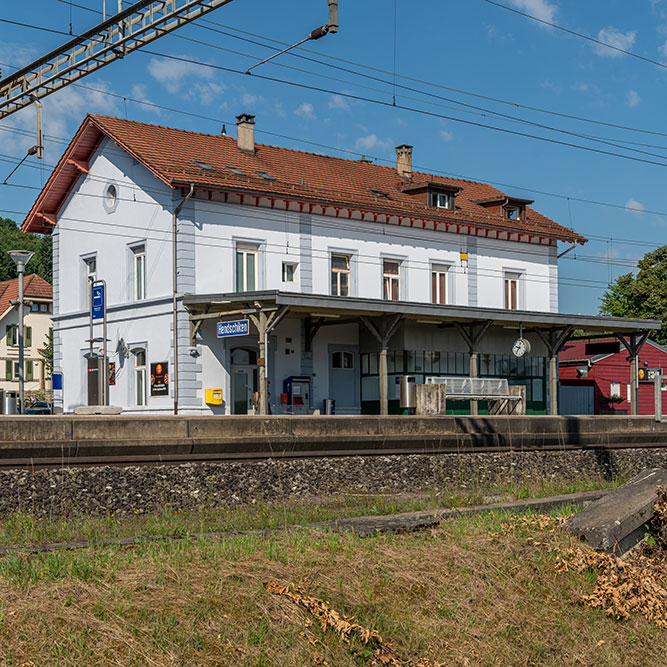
[{"left": 0, "top": 0, "right": 667, "bottom": 313}]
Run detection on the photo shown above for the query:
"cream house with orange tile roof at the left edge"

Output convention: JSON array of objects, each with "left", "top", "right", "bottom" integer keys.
[{"left": 0, "top": 273, "right": 53, "bottom": 395}]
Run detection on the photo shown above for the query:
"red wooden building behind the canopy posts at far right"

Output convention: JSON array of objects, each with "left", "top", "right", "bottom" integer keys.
[{"left": 558, "top": 338, "right": 667, "bottom": 415}]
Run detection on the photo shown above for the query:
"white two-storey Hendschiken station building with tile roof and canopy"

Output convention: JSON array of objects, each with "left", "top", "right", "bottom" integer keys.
[{"left": 22, "top": 115, "right": 660, "bottom": 414}]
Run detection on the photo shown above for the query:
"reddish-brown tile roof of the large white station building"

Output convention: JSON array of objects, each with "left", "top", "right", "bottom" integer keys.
[{"left": 22, "top": 115, "right": 586, "bottom": 243}]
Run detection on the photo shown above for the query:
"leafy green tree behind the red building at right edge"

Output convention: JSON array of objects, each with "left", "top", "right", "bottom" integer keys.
[{"left": 599, "top": 246, "right": 667, "bottom": 344}]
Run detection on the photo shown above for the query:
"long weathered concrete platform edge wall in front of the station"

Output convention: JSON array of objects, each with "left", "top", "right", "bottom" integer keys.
[{"left": 0, "top": 415, "right": 667, "bottom": 459}]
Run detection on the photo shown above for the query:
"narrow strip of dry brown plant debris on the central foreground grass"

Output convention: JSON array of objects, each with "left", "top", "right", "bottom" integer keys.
[{"left": 266, "top": 581, "right": 444, "bottom": 667}]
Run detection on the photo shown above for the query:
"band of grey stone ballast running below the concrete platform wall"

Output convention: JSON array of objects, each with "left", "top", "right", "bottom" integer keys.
[{"left": 0, "top": 449, "right": 667, "bottom": 517}]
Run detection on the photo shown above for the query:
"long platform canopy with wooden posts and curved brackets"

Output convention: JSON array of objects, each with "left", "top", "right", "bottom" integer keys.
[{"left": 183, "top": 290, "right": 662, "bottom": 414}]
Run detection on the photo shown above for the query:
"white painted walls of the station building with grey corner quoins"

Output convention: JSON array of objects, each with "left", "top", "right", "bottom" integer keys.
[{"left": 53, "top": 139, "right": 558, "bottom": 414}]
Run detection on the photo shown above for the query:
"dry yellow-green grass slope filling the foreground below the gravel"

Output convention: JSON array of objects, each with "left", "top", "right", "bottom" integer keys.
[{"left": 0, "top": 508, "right": 667, "bottom": 667}]
